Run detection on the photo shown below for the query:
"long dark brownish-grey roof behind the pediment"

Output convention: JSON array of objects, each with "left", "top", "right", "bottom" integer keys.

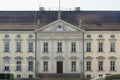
[{"left": 0, "top": 11, "right": 120, "bottom": 31}]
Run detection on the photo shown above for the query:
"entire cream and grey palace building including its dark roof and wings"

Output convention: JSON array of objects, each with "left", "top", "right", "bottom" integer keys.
[{"left": 0, "top": 10, "right": 120, "bottom": 78}]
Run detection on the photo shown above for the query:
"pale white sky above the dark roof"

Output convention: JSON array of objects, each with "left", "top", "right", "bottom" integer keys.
[{"left": 0, "top": 0, "right": 120, "bottom": 11}]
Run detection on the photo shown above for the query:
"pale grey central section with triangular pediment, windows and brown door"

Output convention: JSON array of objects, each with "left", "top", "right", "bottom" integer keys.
[{"left": 36, "top": 19, "right": 83, "bottom": 74}]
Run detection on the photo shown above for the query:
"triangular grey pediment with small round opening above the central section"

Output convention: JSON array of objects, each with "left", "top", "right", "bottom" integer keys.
[{"left": 36, "top": 20, "right": 83, "bottom": 32}]
